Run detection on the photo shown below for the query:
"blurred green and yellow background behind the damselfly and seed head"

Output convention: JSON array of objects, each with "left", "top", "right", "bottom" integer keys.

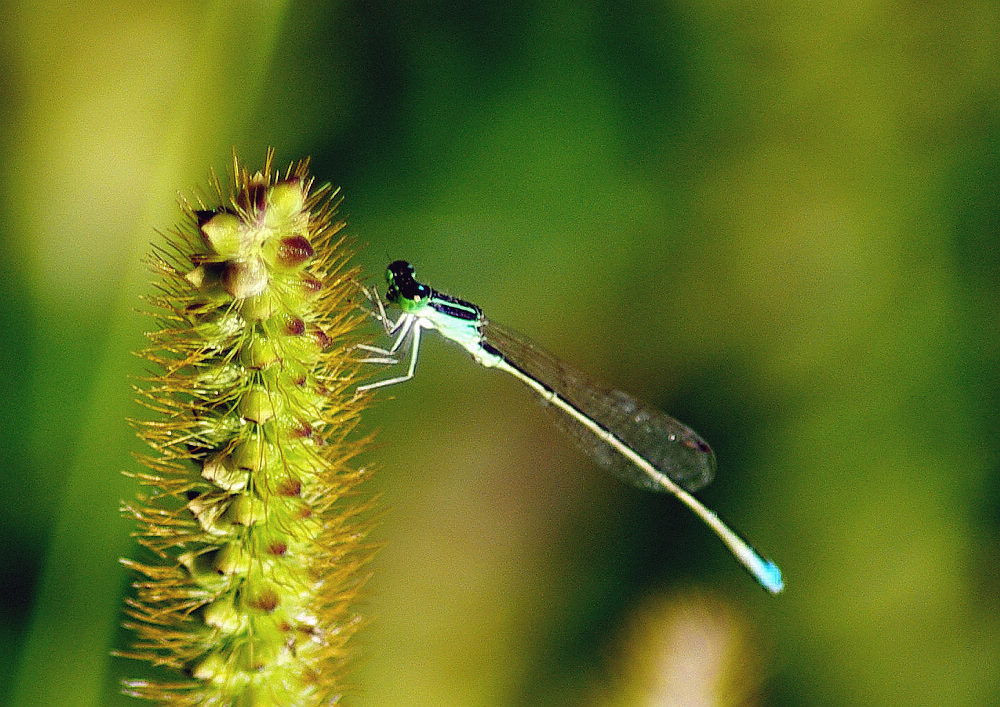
[{"left": 0, "top": 0, "right": 1000, "bottom": 706}]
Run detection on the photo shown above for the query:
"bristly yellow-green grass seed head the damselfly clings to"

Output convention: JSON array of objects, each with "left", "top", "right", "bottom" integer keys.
[{"left": 123, "top": 152, "right": 372, "bottom": 707}]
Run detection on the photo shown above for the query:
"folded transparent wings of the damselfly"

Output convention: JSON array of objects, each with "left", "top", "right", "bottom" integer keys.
[{"left": 481, "top": 322, "right": 715, "bottom": 492}]
